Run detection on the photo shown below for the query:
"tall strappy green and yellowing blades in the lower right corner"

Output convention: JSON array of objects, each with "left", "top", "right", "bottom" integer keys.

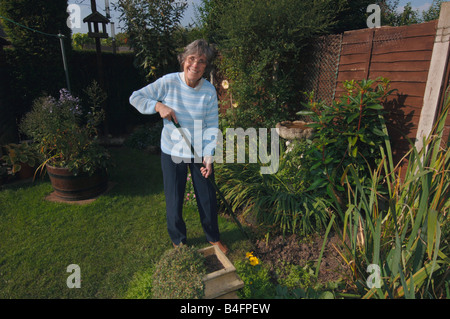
[{"left": 336, "top": 86, "right": 450, "bottom": 299}]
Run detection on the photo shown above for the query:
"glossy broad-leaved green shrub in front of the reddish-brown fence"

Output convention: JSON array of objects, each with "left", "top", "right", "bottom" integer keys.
[{"left": 297, "top": 78, "right": 394, "bottom": 198}]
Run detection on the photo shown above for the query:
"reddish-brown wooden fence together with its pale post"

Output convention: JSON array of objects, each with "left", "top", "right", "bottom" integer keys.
[{"left": 302, "top": 7, "right": 450, "bottom": 169}]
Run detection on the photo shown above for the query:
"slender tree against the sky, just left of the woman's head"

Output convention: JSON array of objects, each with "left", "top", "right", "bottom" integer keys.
[{"left": 117, "top": 0, "right": 187, "bottom": 79}]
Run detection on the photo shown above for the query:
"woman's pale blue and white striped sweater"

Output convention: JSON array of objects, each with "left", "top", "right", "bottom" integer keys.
[{"left": 130, "top": 72, "right": 219, "bottom": 158}]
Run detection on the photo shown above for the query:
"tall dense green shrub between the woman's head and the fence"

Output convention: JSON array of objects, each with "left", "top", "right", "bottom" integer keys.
[{"left": 209, "top": 0, "right": 336, "bottom": 127}]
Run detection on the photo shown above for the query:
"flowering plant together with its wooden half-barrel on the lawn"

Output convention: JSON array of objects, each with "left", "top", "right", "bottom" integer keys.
[{"left": 20, "top": 82, "right": 110, "bottom": 200}]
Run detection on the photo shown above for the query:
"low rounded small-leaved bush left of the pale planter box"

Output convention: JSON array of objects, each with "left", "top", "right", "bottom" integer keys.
[{"left": 153, "top": 245, "right": 206, "bottom": 299}]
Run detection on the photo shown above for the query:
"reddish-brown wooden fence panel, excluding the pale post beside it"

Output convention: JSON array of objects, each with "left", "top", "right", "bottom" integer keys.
[{"left": 336, "top": 21, "right": 437, "bottom": 164}]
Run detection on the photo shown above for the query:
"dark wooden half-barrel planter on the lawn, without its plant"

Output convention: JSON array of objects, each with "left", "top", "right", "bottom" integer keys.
[{"left": 46, "top": 165, "right": 108, "bottom": 201}]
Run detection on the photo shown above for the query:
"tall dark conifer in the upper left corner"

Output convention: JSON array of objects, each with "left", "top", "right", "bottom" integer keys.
[{"left": 0, "top": 0, "right": 71, "bottom": 136}]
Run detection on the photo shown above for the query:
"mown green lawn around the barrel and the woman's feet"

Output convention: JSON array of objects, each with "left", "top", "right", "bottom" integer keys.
[{"left": 0, "top": 148, "right": 248, "bottom": 299}]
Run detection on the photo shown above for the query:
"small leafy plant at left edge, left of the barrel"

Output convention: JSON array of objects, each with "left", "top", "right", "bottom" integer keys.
[{"left": 1, "top": 142, "right": 41, "bottom": 179}]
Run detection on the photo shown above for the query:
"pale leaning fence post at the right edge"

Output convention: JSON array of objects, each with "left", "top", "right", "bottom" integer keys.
[{"left": 415, "top": 2, "right": 450, "bottom": 150}]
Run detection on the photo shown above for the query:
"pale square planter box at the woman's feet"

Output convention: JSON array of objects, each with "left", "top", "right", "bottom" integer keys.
[{"left": 199, "top": 246, "right": 244, "bottom": 299}]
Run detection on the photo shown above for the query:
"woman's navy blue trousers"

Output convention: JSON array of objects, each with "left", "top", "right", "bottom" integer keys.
[{"left": 161, "top": 152, "right": 220, "bottom": 245}]
